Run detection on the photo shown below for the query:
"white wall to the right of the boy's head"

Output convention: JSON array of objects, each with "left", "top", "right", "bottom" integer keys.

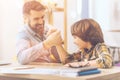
[{"left": 90, "top": 0, "right": 120, "bottom": 47}]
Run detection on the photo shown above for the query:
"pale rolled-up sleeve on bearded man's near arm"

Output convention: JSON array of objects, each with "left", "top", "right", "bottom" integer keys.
[{"left": 16, "top": 39, "right": 49, "bottom": 64}]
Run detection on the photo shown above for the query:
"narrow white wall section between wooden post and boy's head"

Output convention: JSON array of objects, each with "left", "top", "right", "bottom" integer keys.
[{"left": 67, "top": 0, "right": 81, "bottom": 53}]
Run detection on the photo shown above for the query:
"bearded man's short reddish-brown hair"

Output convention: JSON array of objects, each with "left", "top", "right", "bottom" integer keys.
[{"left": 23, "top": 1, "right": 46, "bottom": 14}]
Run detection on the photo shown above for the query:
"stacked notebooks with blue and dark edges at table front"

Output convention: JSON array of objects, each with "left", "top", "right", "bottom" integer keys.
[{"left": 60, "top": 66, "right": 101, "bottom": 77}]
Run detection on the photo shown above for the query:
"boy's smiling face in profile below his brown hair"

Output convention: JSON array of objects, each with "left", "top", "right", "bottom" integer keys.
[{"left": 73, "top": 36, "right": 88, "bottom": 49}]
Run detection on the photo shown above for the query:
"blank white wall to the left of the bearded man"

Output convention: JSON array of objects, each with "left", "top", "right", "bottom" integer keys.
[{"left": 0, "top": 0, "right": 22, "bottom": 60}]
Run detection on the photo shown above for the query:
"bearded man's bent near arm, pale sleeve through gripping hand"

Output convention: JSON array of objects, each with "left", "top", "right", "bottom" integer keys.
[{"left": 17, "top": 31, "right": 61, "bottom": 64}]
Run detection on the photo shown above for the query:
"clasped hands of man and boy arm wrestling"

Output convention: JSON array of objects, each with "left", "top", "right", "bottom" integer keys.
[{"left": 43, "top": 28, "right": 63, "bottom": 49}]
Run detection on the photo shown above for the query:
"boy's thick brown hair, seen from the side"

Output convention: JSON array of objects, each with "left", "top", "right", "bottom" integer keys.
[{"left": 71, "top": 19, "right": 104, "bottom": 46}]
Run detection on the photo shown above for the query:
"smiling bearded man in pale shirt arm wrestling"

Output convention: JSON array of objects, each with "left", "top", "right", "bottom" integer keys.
[{"left": 16, "top": 1, "right": 62, "bottom": 64}]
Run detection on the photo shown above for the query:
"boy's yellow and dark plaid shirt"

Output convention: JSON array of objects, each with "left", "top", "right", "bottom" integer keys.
[{"left": 66, "top": 43, "right": 113, "bottom": 68}]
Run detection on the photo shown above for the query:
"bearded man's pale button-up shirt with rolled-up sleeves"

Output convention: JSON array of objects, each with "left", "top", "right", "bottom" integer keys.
[{"left": 16, "top": 25, "right": 60, "bottom": 64}]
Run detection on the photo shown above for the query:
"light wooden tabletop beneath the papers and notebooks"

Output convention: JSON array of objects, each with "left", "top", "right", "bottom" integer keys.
[{"left": 0, "top": 63, "right": 120, "bottom": 80}]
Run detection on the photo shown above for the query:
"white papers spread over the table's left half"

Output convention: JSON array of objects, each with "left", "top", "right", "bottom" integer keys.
[{"left": 0, "top": 67, "right": 59, "bottom": 74}]
